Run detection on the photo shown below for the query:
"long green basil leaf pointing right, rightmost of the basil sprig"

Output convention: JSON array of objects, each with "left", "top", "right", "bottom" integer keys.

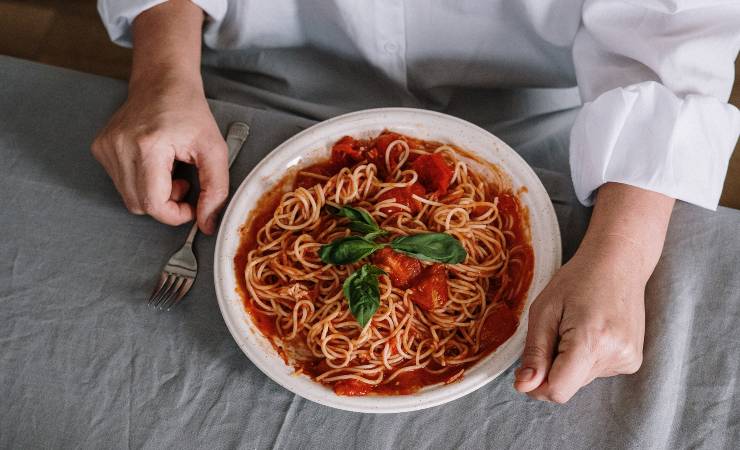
[{"left": 391, "top": 233, "right": 468, "bottom": 264}]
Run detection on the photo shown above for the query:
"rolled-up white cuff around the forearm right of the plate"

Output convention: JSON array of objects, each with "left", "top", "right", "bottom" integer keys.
[{"left": 570, "top": 81, "right": 740, "bottom": 210}]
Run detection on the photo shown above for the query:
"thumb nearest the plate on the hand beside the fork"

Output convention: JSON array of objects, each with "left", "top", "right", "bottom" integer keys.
[{"left": 195, "top": 135, "right": 229, "bottom": 234}]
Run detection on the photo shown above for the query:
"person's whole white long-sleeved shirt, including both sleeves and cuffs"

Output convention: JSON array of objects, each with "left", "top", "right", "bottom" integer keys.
[{"left": 98, "top": 0, "right": 740, "bottom": 209}]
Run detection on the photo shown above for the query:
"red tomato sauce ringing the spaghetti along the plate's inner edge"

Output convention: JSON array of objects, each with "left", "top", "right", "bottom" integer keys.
[{"left": 234, "top": 133, "right": 534, "bottom": 395}]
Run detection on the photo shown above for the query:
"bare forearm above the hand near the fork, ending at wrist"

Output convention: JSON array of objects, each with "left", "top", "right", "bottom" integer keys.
[{"left": 129, "top": 0, "right": 204, "bottom": 90}]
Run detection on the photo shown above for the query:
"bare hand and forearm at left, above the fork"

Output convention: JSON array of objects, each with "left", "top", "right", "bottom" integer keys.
[{"left": 92, "top": 0, "right": 223, "bottom": 234}]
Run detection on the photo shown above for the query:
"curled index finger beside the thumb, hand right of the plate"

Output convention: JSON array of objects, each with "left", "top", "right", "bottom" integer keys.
[{"left": 529, "top": 334, "right": 595, "bottom": 403}]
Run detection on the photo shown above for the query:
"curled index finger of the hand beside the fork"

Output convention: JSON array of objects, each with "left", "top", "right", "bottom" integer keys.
[{"left": 136, "top": 144, "right": 195, "bottom": 225}]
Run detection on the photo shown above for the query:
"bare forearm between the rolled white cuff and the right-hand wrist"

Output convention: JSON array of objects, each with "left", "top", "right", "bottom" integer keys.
[{"left": 579, "top": 183, "right": 675, "bottom": 281}]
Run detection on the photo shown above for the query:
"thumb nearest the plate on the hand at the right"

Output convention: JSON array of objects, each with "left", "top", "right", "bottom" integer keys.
[{"left": 514, "top": 298, "right": 560, "bottom": 392}]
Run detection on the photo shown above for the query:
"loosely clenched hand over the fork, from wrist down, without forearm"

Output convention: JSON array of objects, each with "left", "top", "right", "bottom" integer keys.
[{"left": 92, "top": 77, "right": 229, "bottom": 234}]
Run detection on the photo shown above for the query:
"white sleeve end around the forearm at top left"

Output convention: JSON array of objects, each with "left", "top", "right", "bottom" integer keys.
[{"left": 98, "top": 0, "right": 228, "bottom": 47}]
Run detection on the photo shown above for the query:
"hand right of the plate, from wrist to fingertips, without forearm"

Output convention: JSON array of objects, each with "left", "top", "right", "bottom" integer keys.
[{"left": 514, "top": 238, "right": 647, "bottom": 403}]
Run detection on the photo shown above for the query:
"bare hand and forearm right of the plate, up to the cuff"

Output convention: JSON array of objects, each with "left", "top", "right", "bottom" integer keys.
[{"left": 514, "top": 183, "right": 675, "bottom": 403}]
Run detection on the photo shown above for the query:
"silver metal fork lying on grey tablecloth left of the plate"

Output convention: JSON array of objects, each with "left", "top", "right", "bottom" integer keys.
[{"left": 149, "top": 122, "right": 249, "bottom": 311}]
